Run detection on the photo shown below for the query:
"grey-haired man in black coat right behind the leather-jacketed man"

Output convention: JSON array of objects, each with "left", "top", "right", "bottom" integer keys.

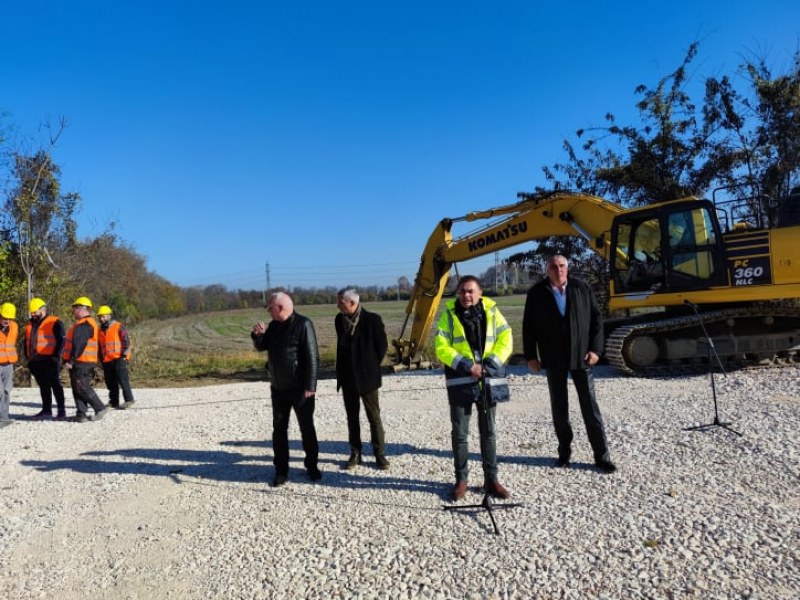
[{"left": 334, "top": 288, "right": 389, "bottom": 471}]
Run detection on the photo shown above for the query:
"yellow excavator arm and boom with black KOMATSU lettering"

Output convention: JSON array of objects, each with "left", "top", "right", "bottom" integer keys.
[{"left": 393, "top": 192, "right": 623, "bottom": 366}]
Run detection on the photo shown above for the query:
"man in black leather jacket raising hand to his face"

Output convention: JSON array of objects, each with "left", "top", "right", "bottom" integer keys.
[{"left": 250, "top": 292, "right": 322, "bottom": 487}]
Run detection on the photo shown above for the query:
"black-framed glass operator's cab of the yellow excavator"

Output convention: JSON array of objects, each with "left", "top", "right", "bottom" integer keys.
[{"left": 611, "top": 200, "right": 727, "bottom": 294}]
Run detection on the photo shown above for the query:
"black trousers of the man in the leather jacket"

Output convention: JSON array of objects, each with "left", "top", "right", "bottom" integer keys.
[{"left": 270, "top": 388, "right": 319, "bottom": 477}]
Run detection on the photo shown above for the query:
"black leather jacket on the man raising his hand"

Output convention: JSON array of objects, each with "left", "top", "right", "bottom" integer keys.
[{"left": 250, "top": 312, "right": 319, "bottom": 391}]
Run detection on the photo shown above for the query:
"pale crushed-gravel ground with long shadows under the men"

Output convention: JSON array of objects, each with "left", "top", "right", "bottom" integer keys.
[{"left": 0, "top": 367, "right": 800, "bottom": 600}]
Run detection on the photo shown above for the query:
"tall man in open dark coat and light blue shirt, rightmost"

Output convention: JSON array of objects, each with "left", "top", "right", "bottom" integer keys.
[{"left": 522, "top": 254, "right": 616, "bottom": 473}]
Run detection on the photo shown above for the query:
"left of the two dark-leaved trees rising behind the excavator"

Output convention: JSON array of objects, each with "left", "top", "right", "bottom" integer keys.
[{"left": 543, "top": 42, "right": 730, "bottom": 206}]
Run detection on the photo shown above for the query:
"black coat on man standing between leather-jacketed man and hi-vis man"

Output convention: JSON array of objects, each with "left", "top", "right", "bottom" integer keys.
[{"left": 334, "top": 306, "right": 389, "bottom": 394}]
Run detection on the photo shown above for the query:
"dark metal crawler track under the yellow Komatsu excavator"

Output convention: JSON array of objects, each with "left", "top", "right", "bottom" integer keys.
[{"left": 605, "top": 306, "right": 800, "bottom": 377}]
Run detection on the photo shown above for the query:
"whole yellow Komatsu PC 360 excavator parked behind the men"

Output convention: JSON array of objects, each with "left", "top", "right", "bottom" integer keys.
[{"left": 393, "top": 189, "right": 800, "bottom": 375}]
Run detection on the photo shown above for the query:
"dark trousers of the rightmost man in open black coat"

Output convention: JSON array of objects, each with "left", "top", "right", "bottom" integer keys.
[{"left": 547, "top": 366, "right": 611, "bottom": 462}]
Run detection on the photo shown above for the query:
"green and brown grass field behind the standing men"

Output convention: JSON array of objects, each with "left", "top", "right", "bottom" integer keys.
[{"left": 130, "top": 295, "right": 525, "bottom": 387}]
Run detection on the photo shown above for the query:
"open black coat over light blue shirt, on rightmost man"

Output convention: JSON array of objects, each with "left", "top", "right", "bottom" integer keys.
[{"left": 522, "top": 277, "right": 603, "bottom": 370}]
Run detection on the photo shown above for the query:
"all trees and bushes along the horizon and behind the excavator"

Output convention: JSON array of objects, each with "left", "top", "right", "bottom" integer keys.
[{"left": 0, "top": 43, "right": 800, "bottom": 323}]
